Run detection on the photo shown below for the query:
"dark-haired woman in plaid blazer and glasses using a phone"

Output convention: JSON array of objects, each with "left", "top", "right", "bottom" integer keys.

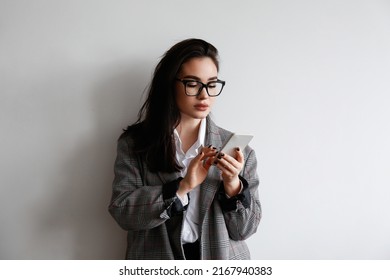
[{"left": 109, "top": 39, "right": 261, "bottom": 259}]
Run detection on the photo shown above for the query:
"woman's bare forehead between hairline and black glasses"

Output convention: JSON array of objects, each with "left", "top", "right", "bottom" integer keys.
[{"left": 180, "top": 57, "right": 218, "bottom": 78}]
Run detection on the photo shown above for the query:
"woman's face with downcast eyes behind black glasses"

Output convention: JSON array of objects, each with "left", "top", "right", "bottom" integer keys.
[{"left": 176, "top": 57, "right": 218, "bottom": 119}]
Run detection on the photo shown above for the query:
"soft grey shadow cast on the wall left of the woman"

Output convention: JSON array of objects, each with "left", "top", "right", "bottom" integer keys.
[{"left": 40, "top": 63, "right": 150, "bottom": 259}]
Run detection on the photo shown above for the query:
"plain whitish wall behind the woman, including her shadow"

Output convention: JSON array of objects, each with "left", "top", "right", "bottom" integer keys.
[{"left": 0, "top": 0, "right": 390, "bottom": 259}]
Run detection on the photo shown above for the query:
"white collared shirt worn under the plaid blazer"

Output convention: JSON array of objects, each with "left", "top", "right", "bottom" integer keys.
[{"left": 174, "top": 118, "right": 206, "bottom": 243}]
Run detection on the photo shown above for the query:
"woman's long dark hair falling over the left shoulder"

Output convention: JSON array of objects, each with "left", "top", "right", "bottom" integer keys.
[{"left": 123, "top": 39, "right": 219, "bottom": 172}]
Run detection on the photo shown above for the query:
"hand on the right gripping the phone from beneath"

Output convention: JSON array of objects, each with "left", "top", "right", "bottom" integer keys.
[{"left": 214, "top": 148, "right": 244, "bottom": 197}]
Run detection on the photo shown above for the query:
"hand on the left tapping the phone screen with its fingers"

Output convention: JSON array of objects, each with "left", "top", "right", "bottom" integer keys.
[{"left": 177, "top": 147, "right": 217, "bottom": 197}]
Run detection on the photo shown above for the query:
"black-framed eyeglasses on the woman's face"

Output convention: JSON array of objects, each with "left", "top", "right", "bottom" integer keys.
[{"left": 176, "top": 79, "right": 225, "bottom": 97}]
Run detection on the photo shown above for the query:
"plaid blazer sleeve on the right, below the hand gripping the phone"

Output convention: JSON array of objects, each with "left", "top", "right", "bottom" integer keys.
[{"left": 222, "top": 147, "right": 262, "bottom": 240}]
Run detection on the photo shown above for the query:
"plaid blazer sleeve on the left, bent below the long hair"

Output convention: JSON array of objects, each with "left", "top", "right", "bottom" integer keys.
[{"left": 108, "top": 137, "right": 183, "bottom": 230}]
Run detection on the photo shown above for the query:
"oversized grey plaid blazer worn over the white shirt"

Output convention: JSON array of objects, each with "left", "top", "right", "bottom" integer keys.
[{"left": 109, "top": 118, "right": 261, "bottom": 260}]
